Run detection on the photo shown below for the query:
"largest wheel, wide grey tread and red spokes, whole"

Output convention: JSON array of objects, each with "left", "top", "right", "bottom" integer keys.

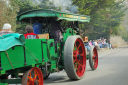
[{"left": 64, "top": 36, "right": 86, "bottom": 79}]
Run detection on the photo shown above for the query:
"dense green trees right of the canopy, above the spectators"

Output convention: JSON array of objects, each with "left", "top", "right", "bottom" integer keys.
[{"left": 73, "top": 0, "right": 126, "bottom": 39}]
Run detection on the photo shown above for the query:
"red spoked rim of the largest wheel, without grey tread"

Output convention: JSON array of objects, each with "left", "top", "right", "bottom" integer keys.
[{"left": 73, "top": 38, "right": 86, "bottom": 77}]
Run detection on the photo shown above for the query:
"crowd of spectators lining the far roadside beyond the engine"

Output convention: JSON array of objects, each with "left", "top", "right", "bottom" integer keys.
[{"left": 85, "top": 38, "right": 113, "bottom": 50}]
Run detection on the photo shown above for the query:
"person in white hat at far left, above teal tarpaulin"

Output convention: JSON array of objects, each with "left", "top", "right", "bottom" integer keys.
[{"left": 0, "top": 23, "right": 13, "bottom": 36}]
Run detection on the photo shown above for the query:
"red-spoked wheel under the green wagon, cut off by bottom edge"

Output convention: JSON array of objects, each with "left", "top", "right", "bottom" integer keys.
[{"left": 22, "top": 67, "right": 43, "bottom": 85}]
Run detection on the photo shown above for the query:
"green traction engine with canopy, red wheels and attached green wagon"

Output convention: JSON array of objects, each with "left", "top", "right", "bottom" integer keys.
[{"left": 0, "top": 9, "right": 98, "bottom": 85}]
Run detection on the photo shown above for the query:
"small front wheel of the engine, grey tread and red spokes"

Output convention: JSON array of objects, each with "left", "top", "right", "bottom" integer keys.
[{"left": 89, "top": 46, "right": 98, "bottom": 70}]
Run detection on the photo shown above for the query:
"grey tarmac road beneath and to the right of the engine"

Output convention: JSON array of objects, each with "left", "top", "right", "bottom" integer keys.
[{"left": 10, "top": 46, "right": 128, "bottom": 85}]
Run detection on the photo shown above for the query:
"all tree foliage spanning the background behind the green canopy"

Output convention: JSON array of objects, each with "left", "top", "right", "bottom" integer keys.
[{"left": 0, "top": 0, "right": 127, "bottom": 39}]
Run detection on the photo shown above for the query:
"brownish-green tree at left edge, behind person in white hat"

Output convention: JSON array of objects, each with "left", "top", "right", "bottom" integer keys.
[{"left": 0, "top": 0, "right": 19, "bottom": 31}]
